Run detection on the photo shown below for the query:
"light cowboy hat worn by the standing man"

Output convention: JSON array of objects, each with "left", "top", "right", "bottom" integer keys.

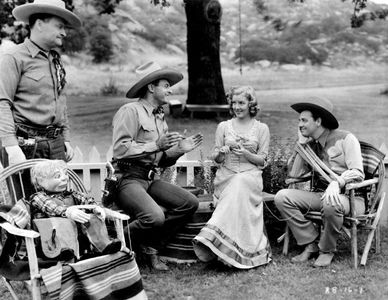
[{"left": 12, "top": 0, "right": 81, "bottom": 28}]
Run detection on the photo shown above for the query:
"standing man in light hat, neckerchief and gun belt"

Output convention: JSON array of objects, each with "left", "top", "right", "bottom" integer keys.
[{"left": 0, "top": 0, "right": 81, "bottom": 166}]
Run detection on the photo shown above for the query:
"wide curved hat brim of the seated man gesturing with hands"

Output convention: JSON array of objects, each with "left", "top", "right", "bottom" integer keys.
[{"left": 126, "top": 68, "right": 183, "bottom": 98}]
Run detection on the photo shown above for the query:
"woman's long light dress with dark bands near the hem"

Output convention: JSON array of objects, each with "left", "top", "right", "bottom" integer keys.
[{"left": 193, "top": 120, "right": 271, "bottom": 269}]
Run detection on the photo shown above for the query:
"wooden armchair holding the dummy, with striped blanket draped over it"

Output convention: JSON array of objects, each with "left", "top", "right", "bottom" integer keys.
[{"left": 0, "top": 159, "right": 147, "bottom": 300}]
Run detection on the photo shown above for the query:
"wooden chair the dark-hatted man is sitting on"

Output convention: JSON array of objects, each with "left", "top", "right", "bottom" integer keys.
[{"left": 278, "top": 142, "right": 385, "bottom": 268}]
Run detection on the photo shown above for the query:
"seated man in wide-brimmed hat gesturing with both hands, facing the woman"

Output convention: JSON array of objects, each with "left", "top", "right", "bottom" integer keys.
[{"left": 113, "top": 62, "right": 202, "bottom": 271}]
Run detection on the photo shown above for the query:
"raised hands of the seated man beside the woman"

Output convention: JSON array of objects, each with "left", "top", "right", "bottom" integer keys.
[{"left": 156, "top": 132, "right": 203, "bottom": 153}]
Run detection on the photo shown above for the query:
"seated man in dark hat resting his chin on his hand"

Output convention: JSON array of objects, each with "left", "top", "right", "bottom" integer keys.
[{"left": 275, "top": 97, "right": 365, "bottom": 267}]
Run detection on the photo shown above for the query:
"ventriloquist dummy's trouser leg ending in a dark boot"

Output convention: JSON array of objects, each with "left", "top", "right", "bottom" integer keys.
[{"left": 83, "top": 215, "right": 121, "bottom": 254}]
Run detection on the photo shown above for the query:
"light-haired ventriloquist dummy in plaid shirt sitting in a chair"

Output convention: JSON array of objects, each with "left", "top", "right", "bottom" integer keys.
[{"left": 30, "top": 160, "right": 121, "bottom": 260}]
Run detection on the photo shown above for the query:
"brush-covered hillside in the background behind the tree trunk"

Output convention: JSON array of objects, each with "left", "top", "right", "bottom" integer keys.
[{"left": 69, "top": 0, "right": 388, "bottom": 67}]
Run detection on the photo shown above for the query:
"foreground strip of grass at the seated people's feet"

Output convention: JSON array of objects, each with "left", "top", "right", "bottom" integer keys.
[{"left": 141, "top": 232, "right": 388, "bottom": 300}]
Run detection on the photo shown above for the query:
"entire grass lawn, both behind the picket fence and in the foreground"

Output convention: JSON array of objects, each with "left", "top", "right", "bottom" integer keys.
[{"left": 0, "top": 65, "right": 388, "bottom": 300}]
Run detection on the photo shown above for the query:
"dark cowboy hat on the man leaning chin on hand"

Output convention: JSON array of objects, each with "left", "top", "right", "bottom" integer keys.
[{"left": 291, "top": 97, "right": 339, "bottom": 129}]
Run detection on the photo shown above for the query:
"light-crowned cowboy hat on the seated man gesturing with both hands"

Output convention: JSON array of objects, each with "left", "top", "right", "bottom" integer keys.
[{"left": 126, "top": 61, "right": 183, "bottom": 98}]
